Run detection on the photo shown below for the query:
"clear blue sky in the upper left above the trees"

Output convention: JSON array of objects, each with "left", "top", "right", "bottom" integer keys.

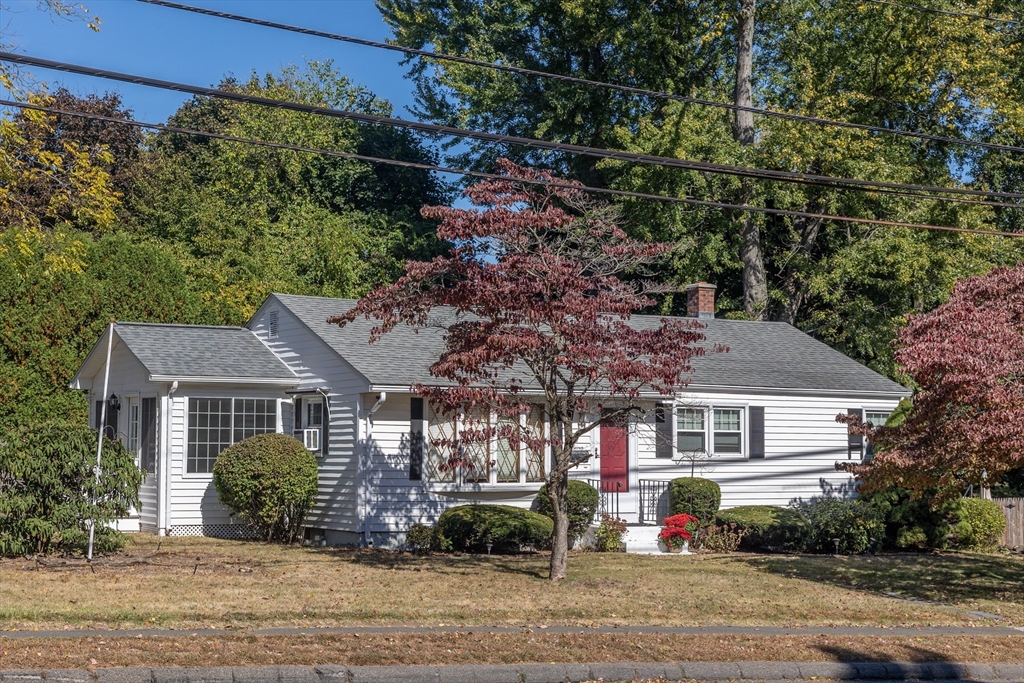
[{"left": 0, "top": 0, "right": 413, "bottom": 122}]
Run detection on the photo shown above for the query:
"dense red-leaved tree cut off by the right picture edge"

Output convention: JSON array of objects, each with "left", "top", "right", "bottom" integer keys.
[{"left": 837, "top": 264, "right": 1024, "bottom": 494}]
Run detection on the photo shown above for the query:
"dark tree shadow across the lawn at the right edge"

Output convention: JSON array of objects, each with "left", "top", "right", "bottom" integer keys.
[{"left": 744, "top": 553, "right": 1024, "bottom": 605}]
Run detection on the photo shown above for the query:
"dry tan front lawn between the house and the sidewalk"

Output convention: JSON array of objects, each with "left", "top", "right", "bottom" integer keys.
[{"left": 0, "top": 535, "right": 1024, "bottom": 629}]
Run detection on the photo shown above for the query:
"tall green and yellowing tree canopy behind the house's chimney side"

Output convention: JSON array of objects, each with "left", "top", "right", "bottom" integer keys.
[{"left": 378, "top": 0, "right": 1024, "bottom": 375}]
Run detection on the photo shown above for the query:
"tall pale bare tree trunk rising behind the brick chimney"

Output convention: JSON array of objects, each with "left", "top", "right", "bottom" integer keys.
[{"left": 732, "top": 0, "right": 768, "bottom": 319}]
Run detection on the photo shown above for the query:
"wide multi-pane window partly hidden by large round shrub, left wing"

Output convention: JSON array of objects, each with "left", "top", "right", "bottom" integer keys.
[{"left": 185, "top": 398, "right": 278, "bottom": 474}]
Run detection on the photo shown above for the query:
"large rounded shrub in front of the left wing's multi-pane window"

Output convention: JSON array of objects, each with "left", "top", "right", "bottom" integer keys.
[{"left": 213, "top": 434, "right": 316, "bottom": 543}]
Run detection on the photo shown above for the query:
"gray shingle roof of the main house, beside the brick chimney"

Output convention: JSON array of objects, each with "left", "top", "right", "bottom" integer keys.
[{"left": 274, "top": 294, "right": 907, "bottom": 394}]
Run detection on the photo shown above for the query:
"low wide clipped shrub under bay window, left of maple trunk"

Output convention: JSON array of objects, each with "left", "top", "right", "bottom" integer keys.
[{"left": 437, "top": 505, "right": 555, "bottom": 553}]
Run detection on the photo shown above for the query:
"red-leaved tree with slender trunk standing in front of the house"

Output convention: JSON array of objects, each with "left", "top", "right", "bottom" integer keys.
[{"left": 330, "top": 160, "right": 705, "bottom": 581}]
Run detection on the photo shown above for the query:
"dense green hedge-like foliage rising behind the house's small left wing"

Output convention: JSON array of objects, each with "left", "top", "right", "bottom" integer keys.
[{"left": 0, "top": 227, "right": 225, "bottom": 432}]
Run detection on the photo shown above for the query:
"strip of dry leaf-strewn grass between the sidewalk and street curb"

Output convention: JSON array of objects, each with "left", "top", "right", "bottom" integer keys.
[{"left": 0, "top": 633, "right": 1024, "bottom": 670}]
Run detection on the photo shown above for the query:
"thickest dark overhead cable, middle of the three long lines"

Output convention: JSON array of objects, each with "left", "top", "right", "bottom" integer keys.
[{"left": 0, "top": 51, "right": 1024, "bottom": 205}]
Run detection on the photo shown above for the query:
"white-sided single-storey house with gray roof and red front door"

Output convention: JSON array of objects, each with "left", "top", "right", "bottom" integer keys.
[{"left": 71, "top": 284, "right": 909, "bottom": 546}]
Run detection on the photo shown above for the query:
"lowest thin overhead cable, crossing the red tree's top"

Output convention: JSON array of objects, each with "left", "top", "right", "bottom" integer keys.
[{"left": 0, "top": 99, "right": 1024, "bottom": 238}]
